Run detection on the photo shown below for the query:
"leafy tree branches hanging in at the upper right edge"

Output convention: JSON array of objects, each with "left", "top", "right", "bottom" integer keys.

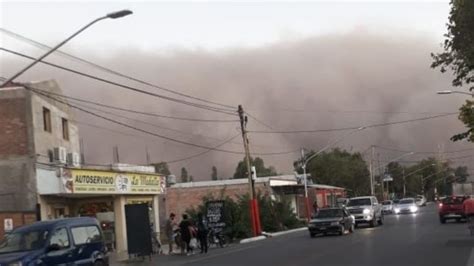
[{"left": 431, "top": 0, "right": 474, "bottom": 141}]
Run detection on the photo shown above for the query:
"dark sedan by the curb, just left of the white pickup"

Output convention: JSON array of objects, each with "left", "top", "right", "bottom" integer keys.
[{"left": 308, "top": 208, "right": 355, "bottom": 237}]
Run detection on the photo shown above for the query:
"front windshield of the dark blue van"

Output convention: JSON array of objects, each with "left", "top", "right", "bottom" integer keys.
[{"left": 0, "top": 230, "right": 48, "bottom": 254}]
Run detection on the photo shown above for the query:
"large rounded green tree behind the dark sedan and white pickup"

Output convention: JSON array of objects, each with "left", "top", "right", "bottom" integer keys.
[{"left": 294, "top": 149, "right": 370, "bottom": 196}]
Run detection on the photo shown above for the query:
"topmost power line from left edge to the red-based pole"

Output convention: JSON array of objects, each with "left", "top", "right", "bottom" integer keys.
[{"left": 0, "top": 28, "right": 234, "bottom": 109}]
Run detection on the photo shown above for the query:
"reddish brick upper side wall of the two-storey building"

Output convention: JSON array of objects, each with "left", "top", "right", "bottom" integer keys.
[{"left": 0, "top": 98, "right": 28, "bottom": 159}]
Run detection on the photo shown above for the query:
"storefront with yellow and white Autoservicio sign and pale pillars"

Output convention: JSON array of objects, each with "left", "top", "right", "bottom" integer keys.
[{"left": 37, "top": 168, "right": 165, "bottom": 258}]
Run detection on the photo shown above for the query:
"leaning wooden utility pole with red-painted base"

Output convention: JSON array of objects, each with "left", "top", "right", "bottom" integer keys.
[{"left": 238, "top": 105, "right": 261, "bottom": 236}]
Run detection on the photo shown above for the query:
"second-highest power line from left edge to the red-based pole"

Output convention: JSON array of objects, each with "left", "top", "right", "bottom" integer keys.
[{"left": 0, "top": 47, "right": 237, "bottom": 116}]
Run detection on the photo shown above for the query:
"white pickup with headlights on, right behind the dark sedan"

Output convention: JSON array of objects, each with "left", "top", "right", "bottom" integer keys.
[{"left": 347, "top": 196, "right": 383, "bottom": 227}]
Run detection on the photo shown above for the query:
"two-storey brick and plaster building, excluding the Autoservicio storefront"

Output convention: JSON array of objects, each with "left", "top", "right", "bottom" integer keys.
[{"left": 0, "top": 81, "right": 80, "bottom": 237}]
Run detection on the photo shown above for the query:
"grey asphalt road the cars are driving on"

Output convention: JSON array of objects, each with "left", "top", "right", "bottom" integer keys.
[{"left": 124, "top": 205, "right": 474, "bottom": 266}]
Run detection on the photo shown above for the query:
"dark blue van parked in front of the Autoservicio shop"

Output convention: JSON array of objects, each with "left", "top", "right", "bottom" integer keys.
[{"left": 0, "top": 217, "right": 109, "bottom": 266}]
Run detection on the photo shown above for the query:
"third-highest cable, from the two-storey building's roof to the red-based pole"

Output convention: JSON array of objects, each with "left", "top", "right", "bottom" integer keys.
[{"left": 33, "top": 89, "right": 239, "bottom": 123}]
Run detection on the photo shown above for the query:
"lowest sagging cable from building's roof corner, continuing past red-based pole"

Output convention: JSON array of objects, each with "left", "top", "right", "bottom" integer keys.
[{"left": 26, "top": 84, "right": 295, "bottom": 155}]
